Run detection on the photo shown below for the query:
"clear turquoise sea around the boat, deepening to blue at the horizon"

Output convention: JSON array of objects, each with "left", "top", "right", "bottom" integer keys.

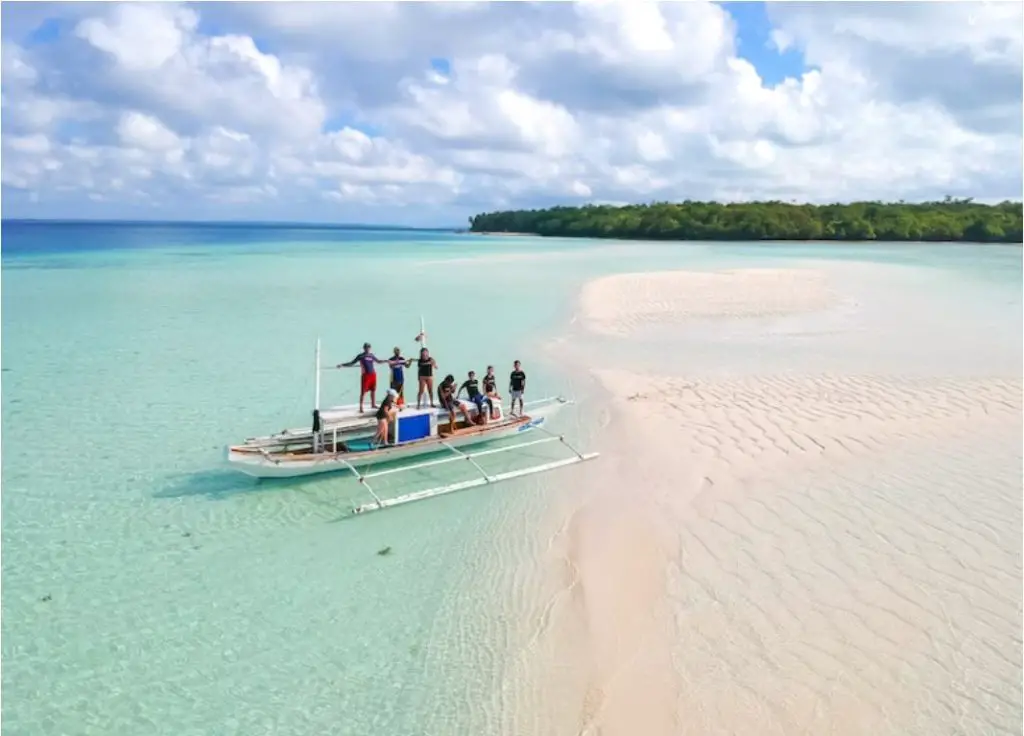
[{"left": 2, "top": 223, "right": 1021, "bottom": 735}]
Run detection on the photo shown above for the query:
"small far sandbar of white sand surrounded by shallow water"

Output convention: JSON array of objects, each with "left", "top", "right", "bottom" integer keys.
[{"left": 580, "top": 268, "right": 837, "bottom": 336}]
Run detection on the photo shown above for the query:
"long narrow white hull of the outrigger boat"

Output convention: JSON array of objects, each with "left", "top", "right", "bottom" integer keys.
[{"left": 226, "top": 397, "right": 570, "bottom": 478}]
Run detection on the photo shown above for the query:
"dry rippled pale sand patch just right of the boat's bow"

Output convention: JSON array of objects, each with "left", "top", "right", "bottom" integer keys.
[{"left": 594, "top": 371, "right": 1022, "bottom": 481}]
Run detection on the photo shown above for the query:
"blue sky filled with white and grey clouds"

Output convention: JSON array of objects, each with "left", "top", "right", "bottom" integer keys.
[{"left": 0, "top": 0, "right": 1024, "bottom": 226}]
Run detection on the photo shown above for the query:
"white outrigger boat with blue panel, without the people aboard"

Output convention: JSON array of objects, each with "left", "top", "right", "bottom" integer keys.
[{"left": 220, "top": 323, "right": 598, "bottom": 514}]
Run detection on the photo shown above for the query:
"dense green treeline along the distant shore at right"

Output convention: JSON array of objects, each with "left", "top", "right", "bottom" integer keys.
[{"left": 469, "top": 197, "right": 1024, "bottom": 243}]
